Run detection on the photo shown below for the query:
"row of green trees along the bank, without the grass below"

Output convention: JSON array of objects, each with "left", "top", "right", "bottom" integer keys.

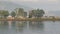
[{"left": 0, "top": 8, "right": 45, "bottom": 18}]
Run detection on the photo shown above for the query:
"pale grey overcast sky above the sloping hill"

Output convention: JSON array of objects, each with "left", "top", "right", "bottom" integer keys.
[{"left": 0, "top": 0, "right": 60, "bottom": 15}]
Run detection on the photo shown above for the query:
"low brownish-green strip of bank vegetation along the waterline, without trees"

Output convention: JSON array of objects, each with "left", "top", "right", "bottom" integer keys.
[{"left": 0, "top": 18, "right": 60, "bottom": 21}]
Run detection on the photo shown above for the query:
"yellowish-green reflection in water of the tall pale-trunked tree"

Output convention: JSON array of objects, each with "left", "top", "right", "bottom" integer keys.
[{"left": 16, "top": 21, "right": 25, "bottom": 34}]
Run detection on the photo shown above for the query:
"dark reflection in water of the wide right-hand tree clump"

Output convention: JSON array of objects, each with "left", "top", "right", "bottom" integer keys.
[{"left": 29, "top": 21, "right": 44, "bottom": 32}]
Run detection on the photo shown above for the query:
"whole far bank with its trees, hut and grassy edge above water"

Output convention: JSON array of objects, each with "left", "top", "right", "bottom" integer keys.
[{"left": 0, "top": 8, "right": 60, "bottom": 21}]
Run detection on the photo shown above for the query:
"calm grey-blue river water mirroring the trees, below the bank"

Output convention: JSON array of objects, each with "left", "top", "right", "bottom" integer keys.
[{"left": 0, "top": 21, "right": 60, "bottom": 34}]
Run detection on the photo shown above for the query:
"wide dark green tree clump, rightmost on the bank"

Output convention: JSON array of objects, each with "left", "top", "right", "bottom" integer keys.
[{"left": 29, "top": 9, "right": 45, "bottom": 17}]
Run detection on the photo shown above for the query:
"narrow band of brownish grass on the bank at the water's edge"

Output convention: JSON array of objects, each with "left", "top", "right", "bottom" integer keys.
[{"left": 0, "top": 18, "right": 60, "bottom": 21}]
